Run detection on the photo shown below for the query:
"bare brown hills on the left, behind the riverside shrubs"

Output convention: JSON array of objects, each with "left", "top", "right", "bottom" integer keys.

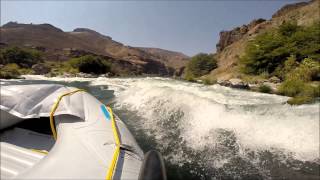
[{"left": 0, "top": 22, "right": 189, "bottom": 75}]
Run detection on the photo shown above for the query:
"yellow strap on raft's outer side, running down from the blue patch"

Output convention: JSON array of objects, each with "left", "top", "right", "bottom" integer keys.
[{"left": 106, "top": 107, "right": 120, "bottom": 180}]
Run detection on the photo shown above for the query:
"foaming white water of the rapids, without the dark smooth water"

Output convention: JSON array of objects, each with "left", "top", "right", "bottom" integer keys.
[{"left": 21, "top": 77, "right": 319, "bottom": 177}]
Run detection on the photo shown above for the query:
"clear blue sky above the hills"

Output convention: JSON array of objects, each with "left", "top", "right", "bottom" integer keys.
[{"left": 1, "top": 0, "right": 301, "bottom": 55}]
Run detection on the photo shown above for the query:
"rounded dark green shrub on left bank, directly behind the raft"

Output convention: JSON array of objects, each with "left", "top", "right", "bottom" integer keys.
[{"left": 66, "top": 55, "right": 111, "bottom": 74}]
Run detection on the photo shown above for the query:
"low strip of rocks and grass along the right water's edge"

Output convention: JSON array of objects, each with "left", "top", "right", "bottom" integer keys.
[{"left": 190, "top": 76, "right": 320, "bottom": 105}]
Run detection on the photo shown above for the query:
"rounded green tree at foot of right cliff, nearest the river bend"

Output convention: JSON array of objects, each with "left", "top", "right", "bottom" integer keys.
[{"left": 185, "top": 53, "right": 217, "bottom": 79}]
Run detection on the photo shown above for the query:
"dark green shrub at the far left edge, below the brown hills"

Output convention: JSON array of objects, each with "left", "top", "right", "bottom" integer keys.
[{"left": 0, "top": 47, "right": 42, "bottom": 68}]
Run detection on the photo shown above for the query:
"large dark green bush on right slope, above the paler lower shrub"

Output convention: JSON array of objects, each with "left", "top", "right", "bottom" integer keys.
[{"left": 240, "top": 22, "right": 320, "bottom": 75}]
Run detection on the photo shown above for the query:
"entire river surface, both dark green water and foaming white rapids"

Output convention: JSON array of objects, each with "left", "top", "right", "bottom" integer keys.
[{"left": 1, "top": 76, "right": 320, "bottom": 179}]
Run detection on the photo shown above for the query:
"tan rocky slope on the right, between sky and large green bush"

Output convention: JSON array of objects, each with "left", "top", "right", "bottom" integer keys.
[{"left": 210, "top": 0, "right": 320, "bottom": 80}]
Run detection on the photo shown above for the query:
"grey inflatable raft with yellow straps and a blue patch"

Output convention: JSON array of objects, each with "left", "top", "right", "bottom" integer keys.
[{"left": 0, "top": 84, "right": 166, "bottom": 180}]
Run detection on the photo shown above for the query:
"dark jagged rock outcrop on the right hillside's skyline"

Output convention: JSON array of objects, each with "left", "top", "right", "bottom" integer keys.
[{"left": 216, "top": 19, "right": 266, "bottom": 52}]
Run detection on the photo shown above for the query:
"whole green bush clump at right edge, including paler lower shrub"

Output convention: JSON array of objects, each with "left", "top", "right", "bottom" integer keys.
[{"left": 240, "top": 22, "right": 320, "bottom": 104}]
